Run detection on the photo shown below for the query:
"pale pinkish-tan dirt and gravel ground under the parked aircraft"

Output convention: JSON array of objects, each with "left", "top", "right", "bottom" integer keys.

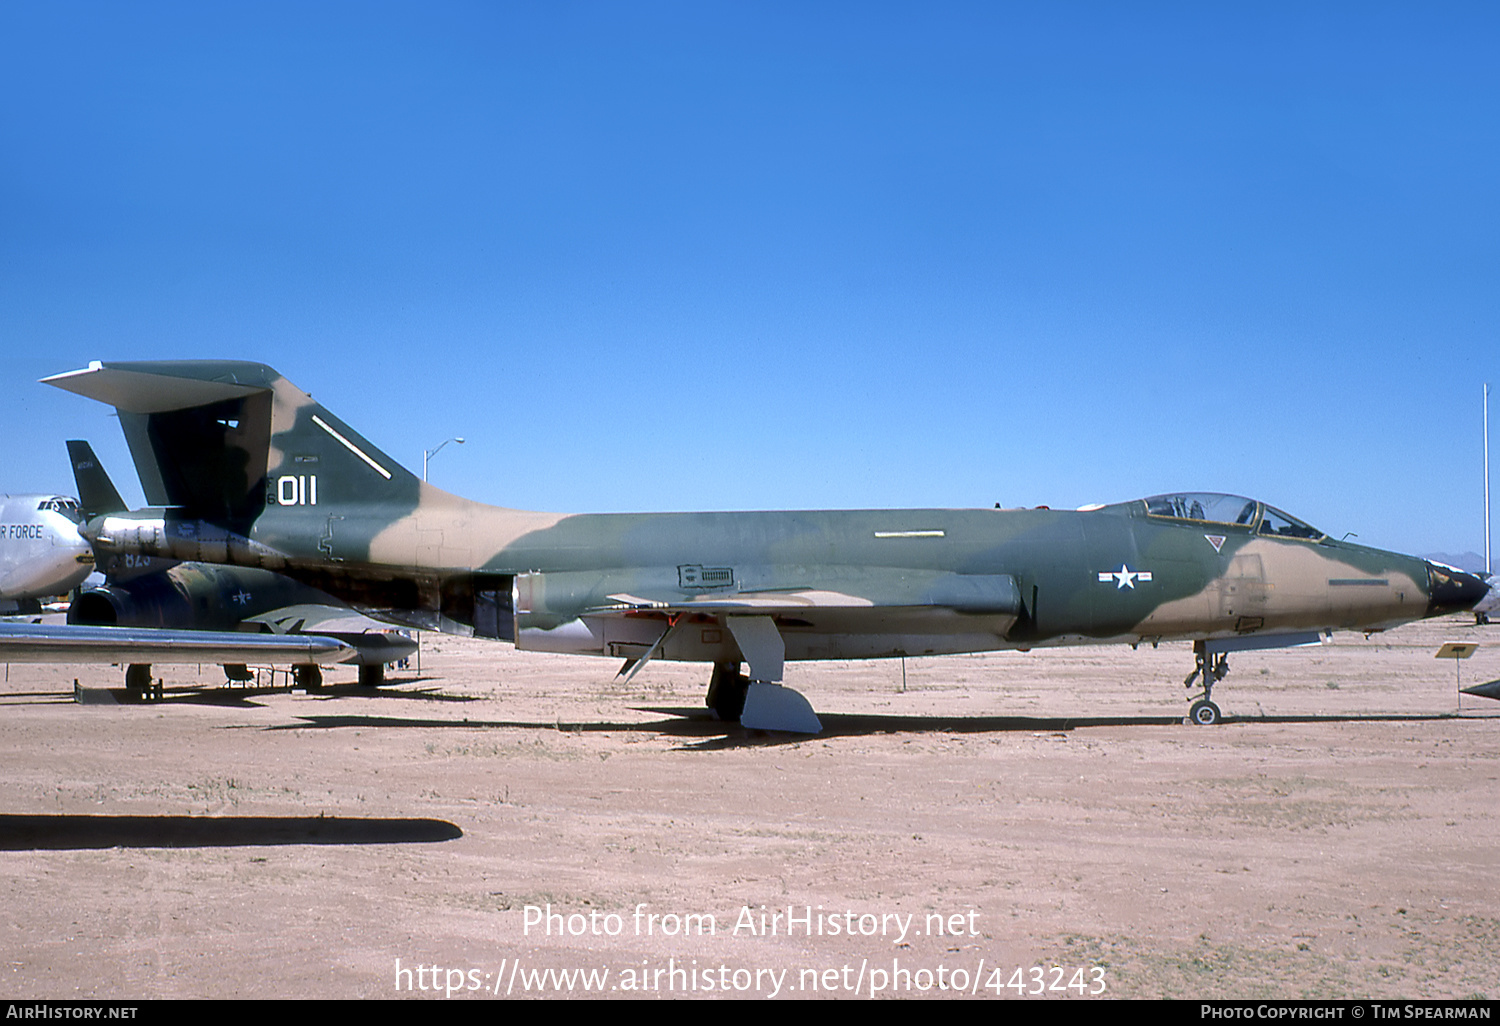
[{"left": 0, "top": 618, "right": 1500, "bottom": 1001}]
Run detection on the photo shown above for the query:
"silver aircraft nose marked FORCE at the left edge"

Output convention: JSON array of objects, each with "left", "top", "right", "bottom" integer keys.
[{"left": 0, "top": 495, "right": 95, "bottom": 614}]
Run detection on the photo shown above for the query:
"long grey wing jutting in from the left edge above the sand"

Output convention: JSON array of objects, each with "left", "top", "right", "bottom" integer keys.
[{"left": 0, "top": 624, "right": 354, "bottom": 663}]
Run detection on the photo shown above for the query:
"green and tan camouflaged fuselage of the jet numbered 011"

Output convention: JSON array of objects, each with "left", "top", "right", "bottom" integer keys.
[{"left": 73, "top": 486, "right": 1487, "bottom": 662}]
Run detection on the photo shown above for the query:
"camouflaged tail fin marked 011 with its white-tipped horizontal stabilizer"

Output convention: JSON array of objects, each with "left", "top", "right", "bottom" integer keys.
[{"left": 44, "top": 360, "right": 422, "bottom": 533}]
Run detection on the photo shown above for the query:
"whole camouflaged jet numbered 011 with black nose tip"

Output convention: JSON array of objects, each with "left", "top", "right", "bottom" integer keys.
[{"left": 45, "top": 360, "right": 1494, "bottom": 731}]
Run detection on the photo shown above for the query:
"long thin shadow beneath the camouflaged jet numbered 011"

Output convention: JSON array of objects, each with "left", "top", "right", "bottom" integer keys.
[{"left": 264, "top": 707, "right": 1482, "bottom": 752}]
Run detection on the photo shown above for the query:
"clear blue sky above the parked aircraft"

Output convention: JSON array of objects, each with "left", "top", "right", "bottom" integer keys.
[{"left": 0, "top": 0, "right": 1500, "bottom": 552}]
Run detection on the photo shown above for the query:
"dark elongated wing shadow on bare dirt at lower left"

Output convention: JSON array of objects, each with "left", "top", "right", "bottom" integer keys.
[{"left": 0, "top": 815, "right": 464, "bottom": 852}]
